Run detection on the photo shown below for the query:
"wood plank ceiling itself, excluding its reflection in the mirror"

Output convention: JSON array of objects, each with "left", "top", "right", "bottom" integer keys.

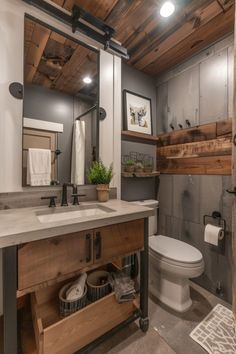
[{"left": 53, "top": 0, "right": 234, "bottom": 75}]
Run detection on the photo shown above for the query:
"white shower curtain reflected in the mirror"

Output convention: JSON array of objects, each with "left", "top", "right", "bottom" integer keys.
[{"left": 71, "top": 120, "right": 85, "bottom": 185}]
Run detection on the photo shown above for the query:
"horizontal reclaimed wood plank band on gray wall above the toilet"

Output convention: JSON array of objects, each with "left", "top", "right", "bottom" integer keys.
[{"left": 157, "top": 119, "right": 232, "bottom": 175}]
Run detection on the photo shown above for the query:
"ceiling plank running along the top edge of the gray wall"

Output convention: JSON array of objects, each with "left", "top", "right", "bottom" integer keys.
[{"left": 143, "top": 6, "right": 234, "bottom": 75}]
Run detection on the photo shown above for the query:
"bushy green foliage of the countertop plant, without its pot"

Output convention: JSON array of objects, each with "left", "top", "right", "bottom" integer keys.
[{"left": 87, "top": 160, "right": 113, "bottom": 184}]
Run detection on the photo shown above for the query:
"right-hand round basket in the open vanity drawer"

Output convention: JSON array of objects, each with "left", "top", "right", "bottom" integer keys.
[{"left": 87, "top": 270, "right": 111, "bottom": 302}]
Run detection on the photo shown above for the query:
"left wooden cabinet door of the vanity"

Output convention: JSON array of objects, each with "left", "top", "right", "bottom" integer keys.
[{"left": 18, "top": 231, "right": 93, "bottom": 290}]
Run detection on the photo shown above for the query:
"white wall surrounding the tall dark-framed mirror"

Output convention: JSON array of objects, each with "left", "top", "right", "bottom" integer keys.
[{"left": 0, "top": 0, "right": 121, "bottom": 314}]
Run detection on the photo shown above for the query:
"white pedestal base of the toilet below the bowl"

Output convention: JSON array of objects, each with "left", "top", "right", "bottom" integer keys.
[{"left": 149, "top": 267, "right": 192, "bottom": 312}]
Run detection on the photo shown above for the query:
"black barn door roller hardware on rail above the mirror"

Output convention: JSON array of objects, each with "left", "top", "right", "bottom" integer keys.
[{"left": 23, "top": 0, "right": 129, "bottom": 59}]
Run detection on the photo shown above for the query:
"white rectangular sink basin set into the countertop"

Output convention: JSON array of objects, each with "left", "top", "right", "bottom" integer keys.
[{"left": 36, "top": 204, "right": 115, "bottom": 224}]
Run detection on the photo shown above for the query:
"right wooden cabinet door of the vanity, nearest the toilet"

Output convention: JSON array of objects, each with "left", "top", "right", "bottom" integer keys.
[{"left": 94, "top": 219, "right": 144, "bottom": 263}]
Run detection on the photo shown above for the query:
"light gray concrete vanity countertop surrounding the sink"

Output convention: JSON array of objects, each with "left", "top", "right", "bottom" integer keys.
[{"left": 0, "top": 199, "right": 154, "bottom": 248}]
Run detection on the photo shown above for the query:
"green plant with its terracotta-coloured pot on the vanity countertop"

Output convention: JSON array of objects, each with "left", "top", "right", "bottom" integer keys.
[{"left": 87, "top": 161, "right": 113, "bottom": 202}]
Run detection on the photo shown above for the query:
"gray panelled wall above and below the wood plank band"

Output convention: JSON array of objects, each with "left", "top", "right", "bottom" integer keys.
[{"left": 157, "top": 42, "right": 232, "bottom": 302}]
